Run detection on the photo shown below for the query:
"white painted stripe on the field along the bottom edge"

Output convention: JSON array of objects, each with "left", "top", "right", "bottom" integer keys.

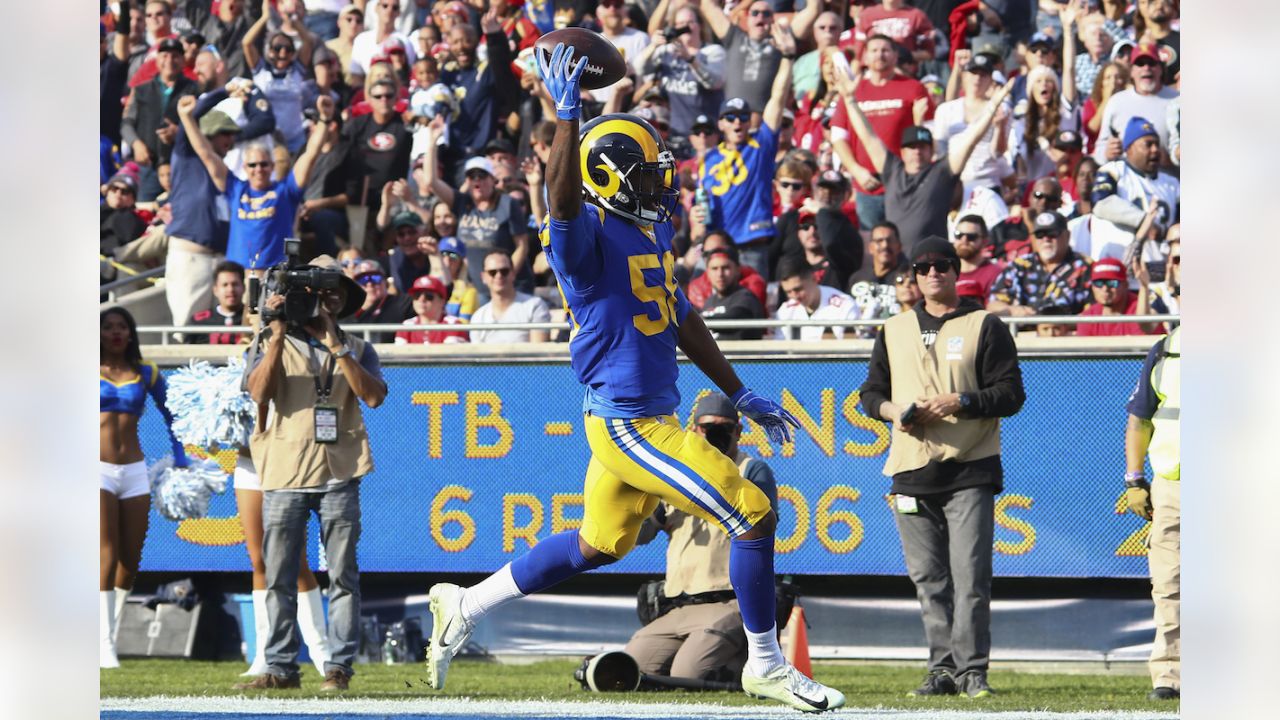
[{"left": 100, "top": 696, "right": 1178, "bottom": 720}]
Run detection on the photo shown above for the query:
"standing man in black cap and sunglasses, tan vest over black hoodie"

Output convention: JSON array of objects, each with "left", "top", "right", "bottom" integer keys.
[{"left": 861, "top": 237, "right": 1027, "bottom": 697}]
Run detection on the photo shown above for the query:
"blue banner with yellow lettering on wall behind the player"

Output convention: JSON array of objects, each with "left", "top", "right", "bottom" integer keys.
[{"left": 140, "top": 359, "right": 1147, "bottom": 578}]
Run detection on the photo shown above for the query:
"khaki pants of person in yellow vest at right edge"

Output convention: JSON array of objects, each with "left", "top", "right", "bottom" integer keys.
[{"left": 1147, "top": 478, "right": 1183, "bottom": 689}]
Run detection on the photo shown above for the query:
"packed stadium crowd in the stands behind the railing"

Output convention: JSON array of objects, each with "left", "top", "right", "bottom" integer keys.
[{"left": 100, "top": 0, "right": 1181, "bottom": 343}]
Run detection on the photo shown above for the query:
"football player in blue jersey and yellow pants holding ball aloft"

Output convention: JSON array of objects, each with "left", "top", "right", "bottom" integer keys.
[{"left": 428, "top": 44, "right": 845, "bottom": 712}]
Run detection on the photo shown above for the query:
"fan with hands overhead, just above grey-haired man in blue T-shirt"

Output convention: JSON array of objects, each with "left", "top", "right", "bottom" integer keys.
[{"left": 241, "top": 3, "right": 316, "bottom": 155}]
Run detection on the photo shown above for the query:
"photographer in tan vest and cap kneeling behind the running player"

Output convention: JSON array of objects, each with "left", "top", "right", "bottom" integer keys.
[{"left": 626, "top": 393, "right": 791, "bottom": 688}]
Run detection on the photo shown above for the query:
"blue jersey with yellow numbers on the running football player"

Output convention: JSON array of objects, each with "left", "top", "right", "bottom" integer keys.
[{"left": 540, "top": 202, "right": 689, "bottom": 418}]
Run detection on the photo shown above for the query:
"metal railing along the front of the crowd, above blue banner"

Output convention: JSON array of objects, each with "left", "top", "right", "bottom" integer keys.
[{"left": 137, "top": 312, "right": 1181, "bottom": 345}]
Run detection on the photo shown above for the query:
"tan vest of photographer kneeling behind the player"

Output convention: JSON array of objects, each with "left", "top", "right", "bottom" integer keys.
[{"left": 663, "top": 452, "right": 753, "bottom": 597}]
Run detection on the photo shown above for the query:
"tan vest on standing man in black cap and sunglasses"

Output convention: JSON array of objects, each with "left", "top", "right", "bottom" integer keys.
[{"left": 883, "top": 310, "right": 1000, "bottom": 477}]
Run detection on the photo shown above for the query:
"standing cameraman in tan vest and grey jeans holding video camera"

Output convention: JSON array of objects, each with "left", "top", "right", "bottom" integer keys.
[{"left": 237, "top": 251, "right": 387, "bottom": 691}]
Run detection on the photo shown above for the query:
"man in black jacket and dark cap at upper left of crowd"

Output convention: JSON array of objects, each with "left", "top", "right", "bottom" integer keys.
[{"left": 120, "top": 37, "right": 197, "bottom": 197}]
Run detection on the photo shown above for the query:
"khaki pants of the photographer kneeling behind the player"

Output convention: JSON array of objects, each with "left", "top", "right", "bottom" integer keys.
[{"left": 626, "top": 600, "right": 746, "bottom": 680}]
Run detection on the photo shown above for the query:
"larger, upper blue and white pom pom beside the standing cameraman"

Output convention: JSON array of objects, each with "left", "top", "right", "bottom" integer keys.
[{"left": 165, "top": 357, "right": 257, "bottom": 447}]
